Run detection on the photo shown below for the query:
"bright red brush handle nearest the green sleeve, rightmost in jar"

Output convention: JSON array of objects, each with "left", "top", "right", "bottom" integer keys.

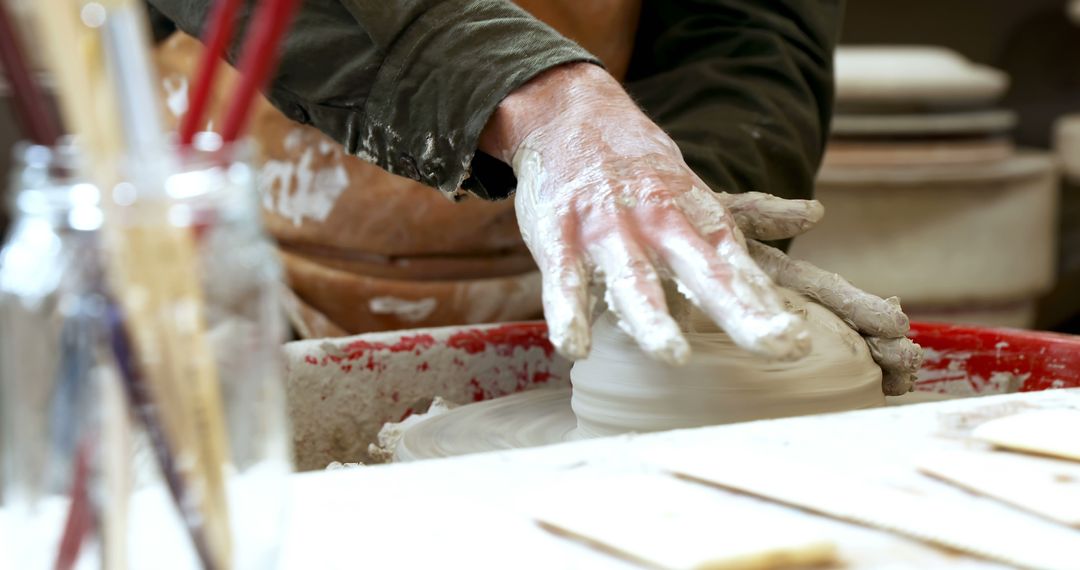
[{"left": 221, "top": 0, "right": 299, "bottom": 141}]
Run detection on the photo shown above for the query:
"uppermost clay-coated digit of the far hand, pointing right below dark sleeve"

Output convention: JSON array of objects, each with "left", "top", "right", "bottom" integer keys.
[{"left": 717, "top": 192, "right": 825, "bottom": 241}]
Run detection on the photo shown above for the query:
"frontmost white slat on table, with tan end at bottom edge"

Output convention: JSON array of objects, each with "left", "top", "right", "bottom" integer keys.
[{"left": 534, "top": 474, "right": 836, "bottom": 570}]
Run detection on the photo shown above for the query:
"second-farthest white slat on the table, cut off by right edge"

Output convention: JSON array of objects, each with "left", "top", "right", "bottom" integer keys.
[{"left": 919, "top": 451, "right": 1080, "bottom": 529}]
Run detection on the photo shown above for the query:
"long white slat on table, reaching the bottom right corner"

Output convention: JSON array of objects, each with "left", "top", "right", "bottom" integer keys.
[{"left": 649, "top": 449, "right": 1080, "bottom": 570}]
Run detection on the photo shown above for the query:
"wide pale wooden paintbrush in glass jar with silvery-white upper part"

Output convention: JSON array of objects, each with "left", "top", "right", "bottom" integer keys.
[{"left": 96, "top": 0, "right": 232, "bottom": 568}]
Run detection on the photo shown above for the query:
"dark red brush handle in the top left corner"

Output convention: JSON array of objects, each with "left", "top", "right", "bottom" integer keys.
[{"left": 0, "top": 2, "right": 60, "bottom": 145}]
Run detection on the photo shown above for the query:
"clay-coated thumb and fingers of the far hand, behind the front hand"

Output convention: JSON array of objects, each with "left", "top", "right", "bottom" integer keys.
[{"left": 734, "top": 192, "right": 922, "bottom": 396}]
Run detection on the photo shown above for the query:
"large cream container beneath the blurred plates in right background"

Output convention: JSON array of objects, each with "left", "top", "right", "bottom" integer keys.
[{"left": 792, "top": 153, "right": 1058, "bottom": 306}]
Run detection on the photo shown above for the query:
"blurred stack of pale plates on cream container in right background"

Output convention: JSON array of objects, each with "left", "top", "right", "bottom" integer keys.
[{"left": 793, "top": 48, "right": 1057, "bottom": 326}]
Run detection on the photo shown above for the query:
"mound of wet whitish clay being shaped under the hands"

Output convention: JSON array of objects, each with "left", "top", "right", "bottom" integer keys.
[{"left": 570, "top": 289, "right": 885, "bottom": 437}]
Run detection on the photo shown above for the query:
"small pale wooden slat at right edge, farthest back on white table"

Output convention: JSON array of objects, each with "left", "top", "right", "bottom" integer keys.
[{"left": 971, "top": 410, "right": 1080, "bottom": 461}]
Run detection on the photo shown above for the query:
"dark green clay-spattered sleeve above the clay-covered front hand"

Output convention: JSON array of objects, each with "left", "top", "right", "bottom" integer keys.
[{"left": 148, "top": 0, "right": 598, "bottom": 199}]
